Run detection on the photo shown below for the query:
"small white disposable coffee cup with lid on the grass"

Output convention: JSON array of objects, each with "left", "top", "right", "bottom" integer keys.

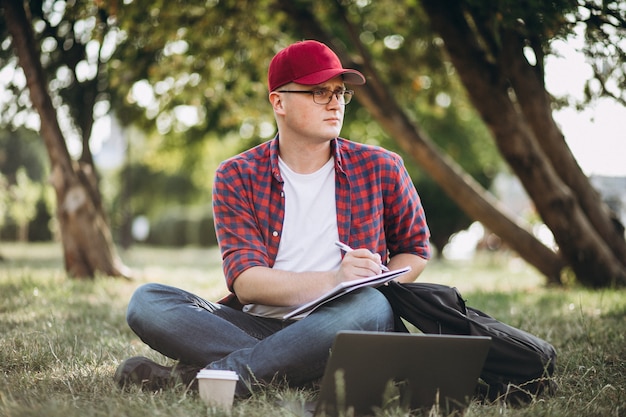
[{"left": 196, "top": 369, "right": 239, "bottom": 410}]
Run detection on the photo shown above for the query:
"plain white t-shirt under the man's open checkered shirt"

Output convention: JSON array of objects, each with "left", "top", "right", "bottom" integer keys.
[{"left": 244, "top": 158, "right": 341, "bottom": 318}]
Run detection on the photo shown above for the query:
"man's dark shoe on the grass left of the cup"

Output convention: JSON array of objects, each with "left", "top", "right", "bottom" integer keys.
[{"left": 113, "top": 356, "right": 200, "bottom": 391}]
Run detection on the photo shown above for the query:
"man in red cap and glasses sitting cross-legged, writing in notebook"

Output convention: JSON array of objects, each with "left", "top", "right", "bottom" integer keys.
[{"left": 115, "top": 40, "right": 430, "bottom": 396}]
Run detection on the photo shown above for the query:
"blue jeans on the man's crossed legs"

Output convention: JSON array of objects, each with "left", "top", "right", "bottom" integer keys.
[{"left": 126, "top": 284, "right": 394, "bottom": 396}]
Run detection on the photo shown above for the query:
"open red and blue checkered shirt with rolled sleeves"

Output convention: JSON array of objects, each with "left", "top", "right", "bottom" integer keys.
[{"left": 213, "top": 137, "right": 431, "bottom": 291}]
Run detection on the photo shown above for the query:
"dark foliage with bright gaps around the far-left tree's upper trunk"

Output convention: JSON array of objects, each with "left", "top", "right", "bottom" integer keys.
[{"left": 0, "top": 1, "right": 110, "bottom": 162}]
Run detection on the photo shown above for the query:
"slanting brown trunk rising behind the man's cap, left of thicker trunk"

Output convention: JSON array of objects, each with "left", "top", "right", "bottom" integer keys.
[{"left": 280, "top": 0, "right": 565, "bottom": 283}]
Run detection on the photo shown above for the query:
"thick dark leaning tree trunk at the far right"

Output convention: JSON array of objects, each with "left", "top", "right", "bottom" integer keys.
[{"left": 422, "top": 0, "right": 626, "bottom": 287}]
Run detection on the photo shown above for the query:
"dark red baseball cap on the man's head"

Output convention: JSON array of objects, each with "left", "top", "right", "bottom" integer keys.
[{"left": 267, "top": 40, "right": 365, "bottom": 91}]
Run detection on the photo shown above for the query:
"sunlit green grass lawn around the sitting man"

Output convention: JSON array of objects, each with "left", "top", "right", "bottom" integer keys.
[{"left": 0, "top": 244, "right": 626, "bottom": 417}]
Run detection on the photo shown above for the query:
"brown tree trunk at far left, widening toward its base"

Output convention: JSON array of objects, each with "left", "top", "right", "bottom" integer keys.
[{"left": 0, "top": 0, "right": 130, "bottom": 278}]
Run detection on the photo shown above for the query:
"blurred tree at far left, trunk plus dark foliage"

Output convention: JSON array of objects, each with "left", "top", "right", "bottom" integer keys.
[{"left": 0, "top": 0, "right": 130, "bottom": 278}]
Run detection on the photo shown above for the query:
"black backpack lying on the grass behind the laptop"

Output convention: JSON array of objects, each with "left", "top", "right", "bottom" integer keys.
[{"left": 378, "top": 281, "right": 556, "bottom": 403}]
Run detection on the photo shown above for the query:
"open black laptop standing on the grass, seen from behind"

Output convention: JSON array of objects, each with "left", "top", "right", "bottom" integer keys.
[{"left": 313, "top": 331, "right": 491, "bottom": 417}]
